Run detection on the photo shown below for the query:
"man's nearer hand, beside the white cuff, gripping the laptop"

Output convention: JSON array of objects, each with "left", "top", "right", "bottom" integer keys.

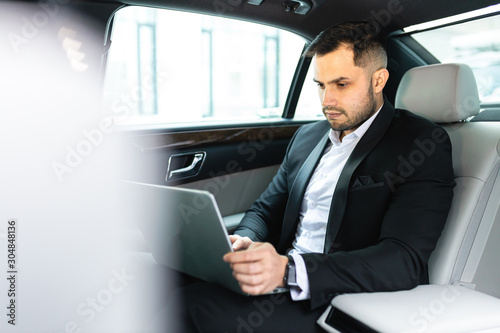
[{"left": 223, "top": 243, "right": 288, "bottom": 295}]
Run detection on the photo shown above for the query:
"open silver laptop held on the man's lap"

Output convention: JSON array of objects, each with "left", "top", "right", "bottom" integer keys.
[{"left": 125, "top": 182, "right": 287, "bottom": 294}]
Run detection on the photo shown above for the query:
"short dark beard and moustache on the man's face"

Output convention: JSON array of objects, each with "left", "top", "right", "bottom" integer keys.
[{"left": 323, "top": 82, "right": 377, "bottom": 132}]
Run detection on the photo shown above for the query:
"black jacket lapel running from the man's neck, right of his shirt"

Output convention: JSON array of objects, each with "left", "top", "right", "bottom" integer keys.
[{"left": 323, "top": 99, "right": 394, "bottom": 253}]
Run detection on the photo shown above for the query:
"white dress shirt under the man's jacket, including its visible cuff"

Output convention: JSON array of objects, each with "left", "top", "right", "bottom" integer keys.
[{"left": 288, "top": 107, "right": 382, "bottom": 301}]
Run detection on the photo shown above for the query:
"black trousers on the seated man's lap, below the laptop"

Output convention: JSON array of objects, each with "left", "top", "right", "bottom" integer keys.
[{"left": 156, "top": 282, "right": 326, "bottom": 333}]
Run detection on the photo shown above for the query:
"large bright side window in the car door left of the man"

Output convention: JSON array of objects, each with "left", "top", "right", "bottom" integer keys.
[{"left": 104, "top": 7, "right": 305, "bottom": 124}]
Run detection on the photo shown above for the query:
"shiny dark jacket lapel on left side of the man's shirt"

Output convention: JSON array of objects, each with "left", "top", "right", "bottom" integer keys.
[{"left": 278, "top": 131, "right": 329, "bottom": 250}]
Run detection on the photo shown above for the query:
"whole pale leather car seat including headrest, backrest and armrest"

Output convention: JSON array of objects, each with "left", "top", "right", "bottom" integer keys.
[{"left": 318, "top": 64, "right": 500, "bottom": 332}]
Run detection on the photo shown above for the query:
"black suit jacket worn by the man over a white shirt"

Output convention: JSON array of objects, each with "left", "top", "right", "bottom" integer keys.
[{"left": 235, "top": 100, "right": 455, "bottom": 308}]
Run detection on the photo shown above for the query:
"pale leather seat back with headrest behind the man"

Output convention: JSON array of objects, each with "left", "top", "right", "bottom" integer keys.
[{"left": 395, "top": 64, "right": 500, "bottom": 297}]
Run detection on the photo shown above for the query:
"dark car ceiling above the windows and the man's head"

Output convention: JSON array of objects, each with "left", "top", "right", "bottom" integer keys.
[{"left": 92, "top": 0, "right": 499, "bottom": 39}]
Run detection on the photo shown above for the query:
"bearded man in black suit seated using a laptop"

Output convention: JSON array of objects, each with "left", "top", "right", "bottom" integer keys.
[{"left": 174, "top": 23, "right": 454, "bottom": 332}]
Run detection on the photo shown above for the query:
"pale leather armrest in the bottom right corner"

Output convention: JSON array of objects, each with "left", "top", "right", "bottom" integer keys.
[{"left": 318, "top": 285, "right": 500, "bottom": 333}]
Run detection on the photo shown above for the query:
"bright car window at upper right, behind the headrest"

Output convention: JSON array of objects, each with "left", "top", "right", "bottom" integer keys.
[{"left": 406, "top": 11, "right": 500, "bottom": 103}]
